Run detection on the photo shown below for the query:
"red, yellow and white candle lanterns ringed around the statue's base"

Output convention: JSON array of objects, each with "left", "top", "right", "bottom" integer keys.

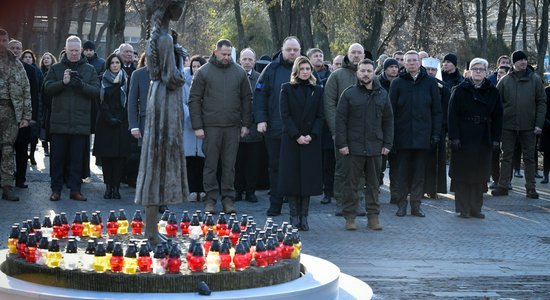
[{"left": 8, "top": 210, "right": 301, "bottom": 274}]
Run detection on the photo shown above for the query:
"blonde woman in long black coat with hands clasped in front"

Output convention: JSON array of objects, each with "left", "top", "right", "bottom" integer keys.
[{"left": 279, "top": 56, "right": 324, "bottom": 231}]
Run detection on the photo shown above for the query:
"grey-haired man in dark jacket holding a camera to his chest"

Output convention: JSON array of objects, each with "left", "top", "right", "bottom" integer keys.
[{"left": 44, "top": 36, "right": 100, "bottom": 201}]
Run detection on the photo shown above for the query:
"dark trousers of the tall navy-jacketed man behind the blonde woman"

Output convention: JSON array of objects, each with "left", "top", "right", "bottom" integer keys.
[{"left": 265, "top": 137, "right": 283, "bottom": 213}]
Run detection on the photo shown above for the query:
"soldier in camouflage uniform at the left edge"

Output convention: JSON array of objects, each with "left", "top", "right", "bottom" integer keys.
[{"left": 0, "top": 28, "right": 31, "bottom": 201}]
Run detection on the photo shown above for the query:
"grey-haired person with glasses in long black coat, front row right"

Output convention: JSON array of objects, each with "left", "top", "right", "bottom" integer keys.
[{"left": 448, "top": 58, "right": 502, "bottom": 219}]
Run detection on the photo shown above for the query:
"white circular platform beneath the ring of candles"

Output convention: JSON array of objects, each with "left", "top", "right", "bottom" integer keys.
[{"left": 0, "top": 250, "right": 372, "bottom": 300}]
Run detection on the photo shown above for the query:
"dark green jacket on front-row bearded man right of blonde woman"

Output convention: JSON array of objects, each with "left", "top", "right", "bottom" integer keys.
[{"left": 336, "top": 81, "right": 393, "bottom": 156}]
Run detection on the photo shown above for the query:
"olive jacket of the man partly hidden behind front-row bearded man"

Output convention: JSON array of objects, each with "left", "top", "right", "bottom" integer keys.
[{"left": 324, "top": 55, "right": 357, "bottom": 135}]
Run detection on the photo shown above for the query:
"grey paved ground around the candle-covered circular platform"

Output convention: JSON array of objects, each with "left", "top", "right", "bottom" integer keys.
[{"left": 0, "top": 145, "right": 550, "bottom": 299}]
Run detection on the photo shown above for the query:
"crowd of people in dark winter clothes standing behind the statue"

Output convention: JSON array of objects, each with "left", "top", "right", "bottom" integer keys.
[{"left": 0, "top": 29, "right": 550, "bottom": 231}]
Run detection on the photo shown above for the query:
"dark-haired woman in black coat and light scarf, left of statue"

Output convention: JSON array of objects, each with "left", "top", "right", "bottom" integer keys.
[{"left": 94, "top": 54, "right": 130, "bottom": 199}]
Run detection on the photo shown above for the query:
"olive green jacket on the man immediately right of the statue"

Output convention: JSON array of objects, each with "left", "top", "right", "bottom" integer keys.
[{"left": 189, "top": 55, "right": 252, "bottom": 130}]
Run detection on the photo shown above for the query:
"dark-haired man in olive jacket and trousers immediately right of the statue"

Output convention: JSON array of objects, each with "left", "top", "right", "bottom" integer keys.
[{"left": 189, "top": 39, "right": 252, "bottom": 213}]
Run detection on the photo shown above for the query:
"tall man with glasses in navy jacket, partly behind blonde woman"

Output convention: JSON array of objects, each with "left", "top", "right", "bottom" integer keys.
[{"left": 253, "top": 36, "right": 300, "bottom": 216}]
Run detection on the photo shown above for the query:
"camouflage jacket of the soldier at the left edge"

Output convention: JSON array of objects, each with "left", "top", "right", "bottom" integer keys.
[{"left": 0, "top": 51, "right": 32, "bottom": 124}]
